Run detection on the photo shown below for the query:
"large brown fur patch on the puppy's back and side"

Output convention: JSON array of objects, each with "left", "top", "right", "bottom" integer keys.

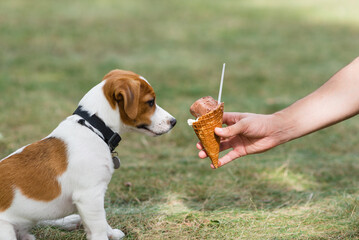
[{"left": 0, "top": 138, "right": 67, "bottom": 212}]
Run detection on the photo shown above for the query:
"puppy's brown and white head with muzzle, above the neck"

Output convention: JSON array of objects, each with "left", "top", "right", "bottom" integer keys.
[{"left": 103, "top": 70, "right": 176, "bottom": 136}]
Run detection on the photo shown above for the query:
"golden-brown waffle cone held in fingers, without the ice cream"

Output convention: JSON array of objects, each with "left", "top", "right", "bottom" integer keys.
[{"left": 192, "top": 103, "right": 224, "bottom": 168}]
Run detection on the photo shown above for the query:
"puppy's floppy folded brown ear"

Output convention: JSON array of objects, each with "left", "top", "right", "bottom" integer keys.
[{"left": 103, "top": 71, "right": 141, "bottom": 119}]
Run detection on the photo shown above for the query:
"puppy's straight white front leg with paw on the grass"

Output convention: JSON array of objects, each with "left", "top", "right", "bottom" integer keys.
[{"left": 74, "top": 189, "right": 125, "bottom": 240}]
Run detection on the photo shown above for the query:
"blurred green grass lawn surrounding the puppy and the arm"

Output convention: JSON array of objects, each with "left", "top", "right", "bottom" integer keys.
[{"left": 0, "top": 0, "right": 359, "bottom": 240}]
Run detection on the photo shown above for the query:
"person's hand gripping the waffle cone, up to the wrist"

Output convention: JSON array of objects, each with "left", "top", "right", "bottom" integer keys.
[{"left": 197, "top": 112, "right": 282, "bottom": 168}]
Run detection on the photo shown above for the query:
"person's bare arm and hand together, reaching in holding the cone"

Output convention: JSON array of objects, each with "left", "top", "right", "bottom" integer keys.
[{"left": 197, "top": 57, "right": 359, "bottom": 167}]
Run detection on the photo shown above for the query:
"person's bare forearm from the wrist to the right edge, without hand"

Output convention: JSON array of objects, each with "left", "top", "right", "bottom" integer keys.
[{"left": 274, "top": 58, "right": 359, "bottom": 142}]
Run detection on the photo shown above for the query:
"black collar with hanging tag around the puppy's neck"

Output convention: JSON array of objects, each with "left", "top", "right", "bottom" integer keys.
[{"left": 73, "top": 106, "right": 121, "bottom": 169}]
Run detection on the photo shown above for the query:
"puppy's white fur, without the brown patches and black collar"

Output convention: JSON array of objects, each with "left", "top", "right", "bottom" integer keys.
[{"left": 0, "top": 77, "right": 173, "bottom": 240}]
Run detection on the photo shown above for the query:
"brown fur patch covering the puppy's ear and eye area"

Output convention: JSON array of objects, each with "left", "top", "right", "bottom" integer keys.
[{"left": 103, "top": 70, "right": 156, "bottom": 127}]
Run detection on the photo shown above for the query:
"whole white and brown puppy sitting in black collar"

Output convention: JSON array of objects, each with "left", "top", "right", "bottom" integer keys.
[{"left": 0, "top": 70, "right": 176, "bottom": 240}]
